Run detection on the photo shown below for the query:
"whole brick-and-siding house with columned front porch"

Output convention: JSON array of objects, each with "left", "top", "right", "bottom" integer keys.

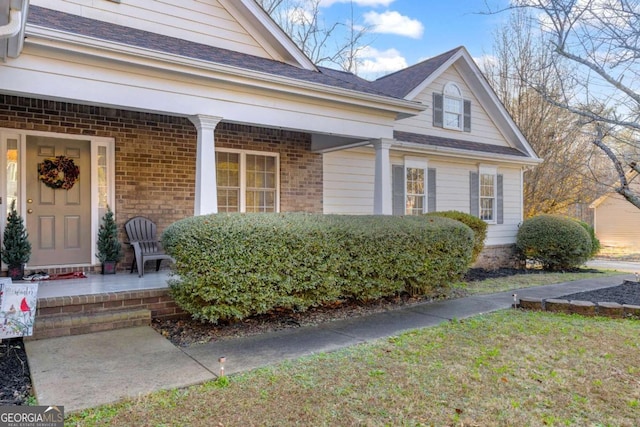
[{"left": 0, "top": 0, "right": 540, "bottom": 272}]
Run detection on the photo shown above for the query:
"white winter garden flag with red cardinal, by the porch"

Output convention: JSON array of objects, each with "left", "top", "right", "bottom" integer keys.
[{"left": 0, "top": 278, "right": 38, "bottom": 340}]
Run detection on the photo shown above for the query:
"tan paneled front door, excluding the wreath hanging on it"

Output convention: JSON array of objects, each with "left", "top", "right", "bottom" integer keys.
[{"left": 25, "top": 135, "right": 93, "bottom": 268}]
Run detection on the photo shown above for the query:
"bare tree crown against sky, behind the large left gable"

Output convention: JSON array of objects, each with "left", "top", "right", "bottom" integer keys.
[{"left": 257, "top": 0, "right": 369, "bottom": 73}]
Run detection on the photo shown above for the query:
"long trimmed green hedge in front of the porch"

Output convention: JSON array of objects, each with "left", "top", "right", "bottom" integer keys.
[{"left": 163, "top": 214, "right": 473, "bottom": 322}]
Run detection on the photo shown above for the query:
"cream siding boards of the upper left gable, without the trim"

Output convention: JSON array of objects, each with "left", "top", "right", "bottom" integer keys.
[{"left": 30, "top": 0, "right": 279, "bottom": 59}]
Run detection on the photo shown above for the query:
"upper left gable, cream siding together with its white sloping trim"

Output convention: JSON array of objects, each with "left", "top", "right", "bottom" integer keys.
[{"left": 31, "top": 0, "right": 316, "bottom": 70}]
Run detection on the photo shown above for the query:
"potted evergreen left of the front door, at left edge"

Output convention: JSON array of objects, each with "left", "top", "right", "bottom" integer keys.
[{"left": 2, "top": 200, "right": 31, "bottom": 280}]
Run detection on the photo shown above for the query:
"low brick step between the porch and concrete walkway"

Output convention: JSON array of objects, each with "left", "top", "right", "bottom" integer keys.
[{"left": 28, "top": 308, "right": 151, "bottom": 340}]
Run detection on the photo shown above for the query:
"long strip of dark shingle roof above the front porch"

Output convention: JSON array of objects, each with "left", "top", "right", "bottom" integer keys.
[{"left": 28, "top": 6, "right": 394, "bottom": 98}]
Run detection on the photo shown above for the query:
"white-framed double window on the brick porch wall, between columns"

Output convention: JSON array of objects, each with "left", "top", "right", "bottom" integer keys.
[{"left": 216, "top": 149, "right": 280, "bottom": 212}]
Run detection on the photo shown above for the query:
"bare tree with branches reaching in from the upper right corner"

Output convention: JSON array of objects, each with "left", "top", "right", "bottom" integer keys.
[{"left": 488, "top": 0, "right": 640, "bottom": 208}]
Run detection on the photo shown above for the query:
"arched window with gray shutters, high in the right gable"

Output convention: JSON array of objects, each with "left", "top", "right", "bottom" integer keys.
[{"left": 433, "top": 83, "right": 471, "bottom": 132}]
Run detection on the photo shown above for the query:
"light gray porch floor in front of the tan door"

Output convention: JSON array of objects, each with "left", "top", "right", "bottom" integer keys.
[{"left": 38, "top": 270, "right": 169, "bottom": 298}]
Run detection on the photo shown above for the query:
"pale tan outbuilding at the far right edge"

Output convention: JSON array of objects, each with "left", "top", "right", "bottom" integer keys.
[{"left": 589, "top": 172, "right": 640, "bottom": 251}]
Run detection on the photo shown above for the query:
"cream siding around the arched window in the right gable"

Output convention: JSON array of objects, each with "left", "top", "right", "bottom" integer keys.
[{"left": 396, "top": 67, "right": 509, "bottom": 146}]
